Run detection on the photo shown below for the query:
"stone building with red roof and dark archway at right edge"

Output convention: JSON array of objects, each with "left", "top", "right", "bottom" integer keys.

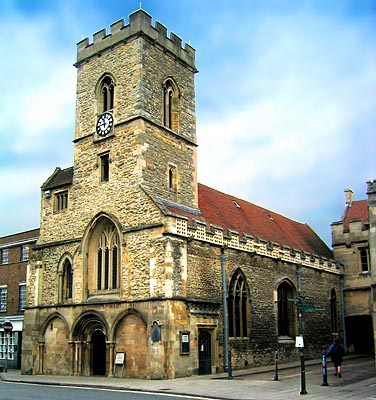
[{"left": 332, "top": 180, "right": 376, "bottom": 354}]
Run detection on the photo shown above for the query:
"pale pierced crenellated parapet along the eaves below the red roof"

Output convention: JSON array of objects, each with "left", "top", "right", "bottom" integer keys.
[{"left": 173, "top": 217, "right": 341, "bottom": 274}]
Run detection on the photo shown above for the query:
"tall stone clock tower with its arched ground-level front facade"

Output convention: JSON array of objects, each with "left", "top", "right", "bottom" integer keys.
[{"left": 23, "top": 10, "right": 197, "bottom": 378}]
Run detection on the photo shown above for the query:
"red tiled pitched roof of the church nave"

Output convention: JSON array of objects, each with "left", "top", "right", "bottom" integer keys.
[{"left": 168, "top": 184, "right": 333, "bottom": 258}]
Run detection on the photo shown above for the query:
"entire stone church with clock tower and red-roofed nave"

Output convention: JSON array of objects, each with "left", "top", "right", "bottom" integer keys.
[{"left": 22, "top": 10, "right": 342, "bottom": 379}]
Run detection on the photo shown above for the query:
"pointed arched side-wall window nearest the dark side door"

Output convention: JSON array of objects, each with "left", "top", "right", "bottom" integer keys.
[{"left": 228, "top": 269, "right": 249, "bottom": 337}]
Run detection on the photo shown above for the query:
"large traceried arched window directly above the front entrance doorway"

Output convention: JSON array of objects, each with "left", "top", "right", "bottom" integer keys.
[{"left": 96, "top": 225, "right": 119, "bottom": 290}]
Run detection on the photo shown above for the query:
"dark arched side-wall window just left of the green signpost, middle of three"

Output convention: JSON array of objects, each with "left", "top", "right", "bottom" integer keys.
[{"left": 277, "top": 281, "right": 296, "bottom": 337}]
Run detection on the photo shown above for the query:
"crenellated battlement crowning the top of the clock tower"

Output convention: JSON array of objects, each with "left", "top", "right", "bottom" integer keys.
[{"left": 77, "top": 10, "right": 196, "bottom": 70}]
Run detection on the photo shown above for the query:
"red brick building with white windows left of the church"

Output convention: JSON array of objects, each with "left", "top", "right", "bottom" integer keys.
[{"left": 0, "top": 229, "right": 39, "bottom": 368}]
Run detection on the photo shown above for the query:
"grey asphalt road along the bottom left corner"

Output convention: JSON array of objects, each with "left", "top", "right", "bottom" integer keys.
[{"left": 0, "top": 381, "right": 217, "bottom": 400}]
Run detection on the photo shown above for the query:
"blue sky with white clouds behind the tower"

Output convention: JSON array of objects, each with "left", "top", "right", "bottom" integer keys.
[{"left": 0, "top": 0, "right": 376, "bottom": 246}]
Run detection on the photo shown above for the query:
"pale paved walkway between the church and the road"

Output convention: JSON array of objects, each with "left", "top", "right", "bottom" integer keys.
[{"left": 0, "top": 359, "right": 376, "bottom": 400}]
